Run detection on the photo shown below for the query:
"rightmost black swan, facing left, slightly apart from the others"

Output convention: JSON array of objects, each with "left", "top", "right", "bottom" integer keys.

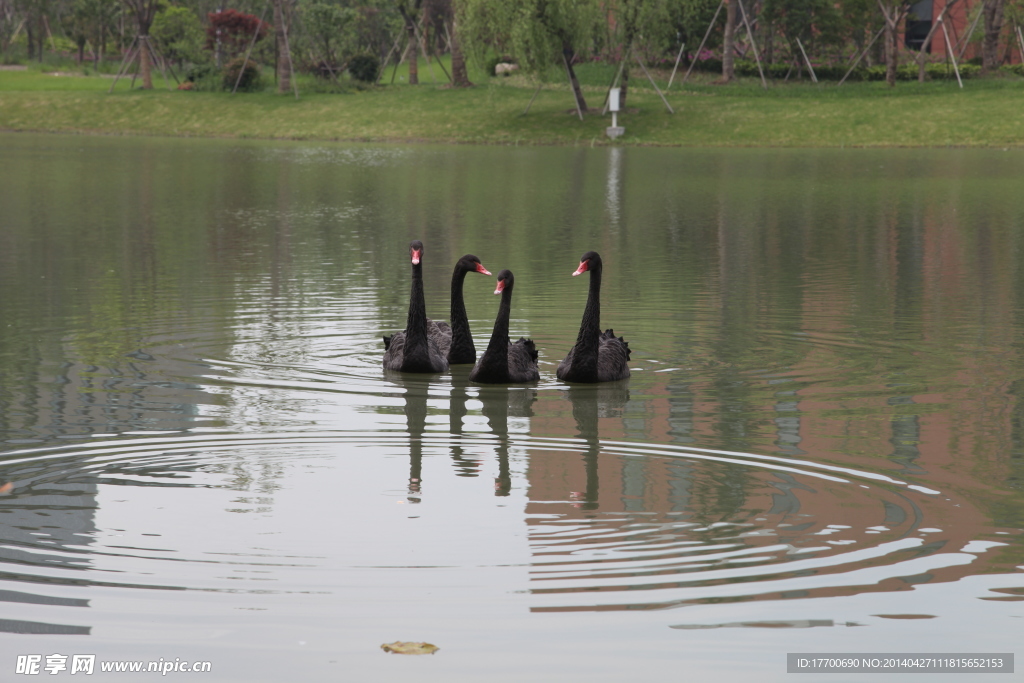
[{"left": 555, "top": 251, "right": 630, "bottom": 383}]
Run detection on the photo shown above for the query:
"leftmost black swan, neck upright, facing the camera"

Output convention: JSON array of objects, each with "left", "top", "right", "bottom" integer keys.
[{"left": 384, "top": 240, "right": 451, "bottom": 373}]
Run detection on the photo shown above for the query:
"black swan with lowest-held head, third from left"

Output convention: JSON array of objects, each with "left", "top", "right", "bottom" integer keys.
[{"left": 469, "top": 270, "right": 541, "bottom": 384}]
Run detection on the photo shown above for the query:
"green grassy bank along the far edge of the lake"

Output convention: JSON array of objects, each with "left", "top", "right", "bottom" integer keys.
[{"left": 6, "top": 60, "right": 1024, "bottom": 146}]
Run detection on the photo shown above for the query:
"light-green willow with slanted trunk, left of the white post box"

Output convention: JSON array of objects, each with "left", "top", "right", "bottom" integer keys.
[{"left": 459, "top": 0, "right": 604, "bottom": 112}]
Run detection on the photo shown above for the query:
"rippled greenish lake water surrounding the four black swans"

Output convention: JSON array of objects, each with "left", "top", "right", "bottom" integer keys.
[{"left": 0, "top": 134, "right": 1024, "bottom": 682}]
